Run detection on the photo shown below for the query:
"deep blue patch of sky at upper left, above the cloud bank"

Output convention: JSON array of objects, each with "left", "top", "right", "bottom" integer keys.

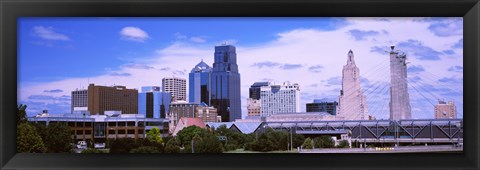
[{"left": 19, "top": 18, "right": 346, "bottom": 82}]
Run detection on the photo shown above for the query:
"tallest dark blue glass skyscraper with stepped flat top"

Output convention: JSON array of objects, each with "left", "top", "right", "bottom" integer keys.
[{"left": 211, "top": 45, "right": 242, "bottom": 122}]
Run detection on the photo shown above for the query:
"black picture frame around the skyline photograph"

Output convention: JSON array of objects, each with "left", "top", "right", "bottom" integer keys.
[{"left": 0, "top": 0, "right": 480, "bottom": 169}]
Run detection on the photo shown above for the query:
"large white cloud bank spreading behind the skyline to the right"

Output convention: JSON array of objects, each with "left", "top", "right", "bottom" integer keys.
[{"left": 19, "top": 18, "right": 463, "bottom": 119}]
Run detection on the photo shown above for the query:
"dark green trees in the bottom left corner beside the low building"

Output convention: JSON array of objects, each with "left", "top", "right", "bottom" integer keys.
[{"left": 17, "top": 104, "right": 73, "bottom": 153}]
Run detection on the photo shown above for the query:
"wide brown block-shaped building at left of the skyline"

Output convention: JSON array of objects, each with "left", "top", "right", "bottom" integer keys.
[{"left": 88, "top": 84, "right": 138, "bottom": 115}]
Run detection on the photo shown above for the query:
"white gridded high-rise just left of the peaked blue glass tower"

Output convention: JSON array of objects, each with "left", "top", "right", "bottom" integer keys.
[{"left": 162, "top": 77, "right": 187, "bottom": 101}]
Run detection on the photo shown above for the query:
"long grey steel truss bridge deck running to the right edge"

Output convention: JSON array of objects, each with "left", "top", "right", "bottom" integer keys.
[{"left": 264, "top": 119, "right": 463, "bottom": 144}]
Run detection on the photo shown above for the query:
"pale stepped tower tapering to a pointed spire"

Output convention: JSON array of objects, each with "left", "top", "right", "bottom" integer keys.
[{"left": 337, "top": 50, "right": 369, "bottom": 120}]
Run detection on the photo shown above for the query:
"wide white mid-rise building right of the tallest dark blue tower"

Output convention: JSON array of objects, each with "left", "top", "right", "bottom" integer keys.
[{"left": 260, "top": 81, "right": 300, "bottom": 117}]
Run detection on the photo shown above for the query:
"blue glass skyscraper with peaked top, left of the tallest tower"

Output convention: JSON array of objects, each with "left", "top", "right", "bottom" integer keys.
[{"left": 188, "top": 60, "right": 212, "bottom": 105}]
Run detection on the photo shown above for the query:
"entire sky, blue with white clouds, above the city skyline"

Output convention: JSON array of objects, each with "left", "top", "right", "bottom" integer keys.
[{"left": 18, "top": 18, "right": 463, "bottom": 118}]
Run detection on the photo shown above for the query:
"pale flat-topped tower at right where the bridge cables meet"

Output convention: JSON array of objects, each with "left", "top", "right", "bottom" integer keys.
[{"left": 390, "top": 46, "right": 412, "bottom": 120}]
